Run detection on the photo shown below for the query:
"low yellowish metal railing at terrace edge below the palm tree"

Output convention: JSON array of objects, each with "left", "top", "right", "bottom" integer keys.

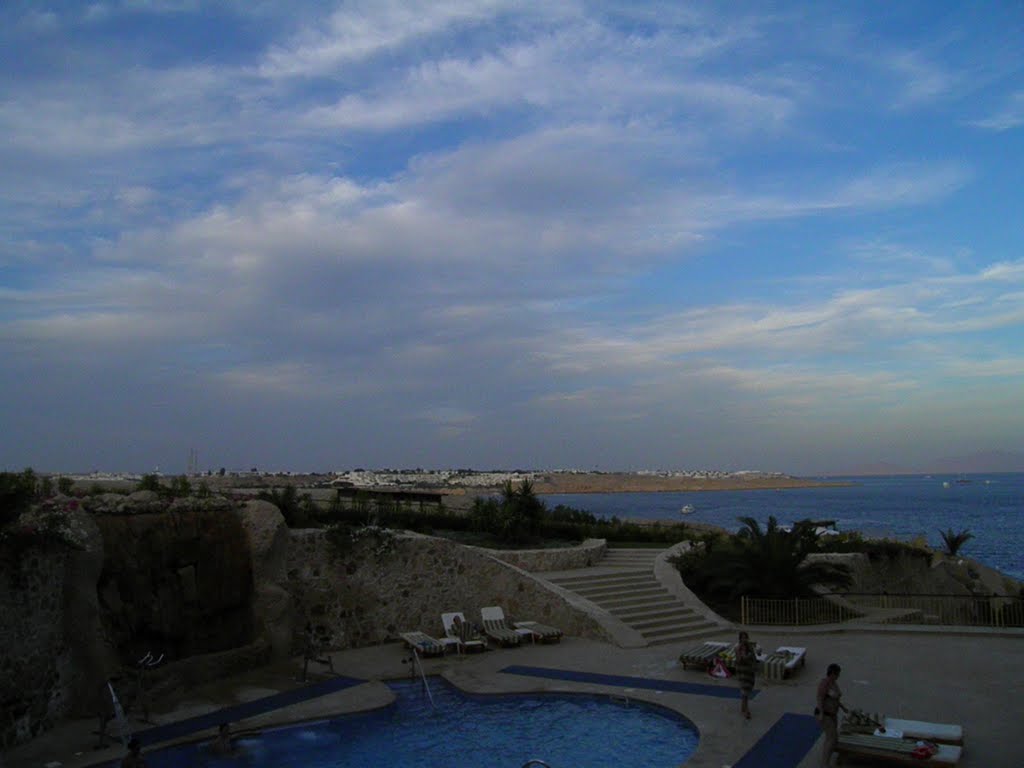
[{"left": 740, "top": 592, "right": 1024, "bottom": 627}]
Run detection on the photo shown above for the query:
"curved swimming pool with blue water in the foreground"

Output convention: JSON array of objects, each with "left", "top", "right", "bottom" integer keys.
[{"left": 134, "top": 678, "right": 699, "bottom": 768}]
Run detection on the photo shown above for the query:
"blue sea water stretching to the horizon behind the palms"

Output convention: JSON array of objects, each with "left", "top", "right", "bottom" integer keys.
[{"left": 543, "top": 473, "right": 1024, "bottom": 580}]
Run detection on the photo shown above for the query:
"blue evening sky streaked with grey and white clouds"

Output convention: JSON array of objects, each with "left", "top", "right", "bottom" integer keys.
[{"left": 0, "top": 0, "right": 1024, "bottom": 474}]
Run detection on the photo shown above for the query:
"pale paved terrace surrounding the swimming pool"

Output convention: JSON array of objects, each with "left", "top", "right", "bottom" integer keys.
[{"left": 3, "top": 628, "right": 1024, "bottom": 768}]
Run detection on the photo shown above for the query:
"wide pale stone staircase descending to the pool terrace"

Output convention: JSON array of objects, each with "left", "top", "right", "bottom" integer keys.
[{"left": 536, "top": 549, "right": 727, "bottom": 645}]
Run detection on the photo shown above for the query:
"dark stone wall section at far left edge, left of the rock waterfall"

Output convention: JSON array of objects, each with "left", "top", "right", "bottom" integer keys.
[{"left": 0, "top": 543, "right": 71, "bottom": 749}]
